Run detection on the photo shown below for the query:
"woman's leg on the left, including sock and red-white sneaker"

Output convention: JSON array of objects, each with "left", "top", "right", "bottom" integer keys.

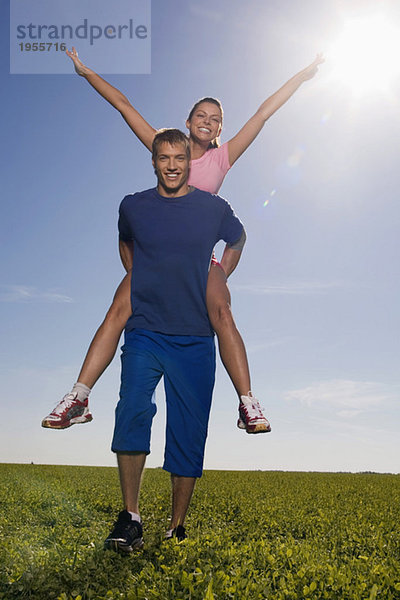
[{"left": 42, "top": 272, "right": 132, "bottom": 429}]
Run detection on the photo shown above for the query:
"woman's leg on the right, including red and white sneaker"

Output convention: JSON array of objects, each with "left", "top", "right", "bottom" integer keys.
[{"left": 206, "top": 262, "right": 271, "bottom": 433}]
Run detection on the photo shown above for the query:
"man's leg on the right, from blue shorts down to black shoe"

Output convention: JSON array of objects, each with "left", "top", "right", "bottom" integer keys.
[{"left": 160, "top": 336, "right": 215, "bottom": 541}]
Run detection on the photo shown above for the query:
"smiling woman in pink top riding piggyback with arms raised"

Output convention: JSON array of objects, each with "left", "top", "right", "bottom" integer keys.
[{"left": 42, "top": 48, "right": 323, "bottom": 433}]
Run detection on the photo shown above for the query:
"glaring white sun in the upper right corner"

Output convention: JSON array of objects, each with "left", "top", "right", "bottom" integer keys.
[{"left": 328, "top": 15, "right": 400, "bottom": 95}]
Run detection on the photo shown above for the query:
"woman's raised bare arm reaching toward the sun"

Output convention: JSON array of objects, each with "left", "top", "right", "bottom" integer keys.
[{"left": 228, "top": 54, "right": 324, "bottom": 166}]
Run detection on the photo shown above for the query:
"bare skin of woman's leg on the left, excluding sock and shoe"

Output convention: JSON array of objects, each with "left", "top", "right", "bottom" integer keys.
[{"left": 78, "top": 271, "right": 132, "bottom": 388}]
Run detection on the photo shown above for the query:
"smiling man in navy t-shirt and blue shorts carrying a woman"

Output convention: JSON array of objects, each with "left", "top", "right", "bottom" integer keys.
[{"left": 105, "top": 129, "right": 245, "bottom": 552}]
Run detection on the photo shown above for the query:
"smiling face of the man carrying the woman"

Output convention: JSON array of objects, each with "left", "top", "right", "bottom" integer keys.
[{"left": 153, "top": 142, "right": 189, "bottom": 196}]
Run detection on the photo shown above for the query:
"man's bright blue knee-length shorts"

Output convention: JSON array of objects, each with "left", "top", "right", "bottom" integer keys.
[{"left": 111, "top": 329, "right": 215, "bottom": 477}]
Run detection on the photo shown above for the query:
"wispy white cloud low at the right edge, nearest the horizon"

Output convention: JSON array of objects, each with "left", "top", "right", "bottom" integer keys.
[{"left": 285, "top": 379, "right": 398, "bottom": 417}]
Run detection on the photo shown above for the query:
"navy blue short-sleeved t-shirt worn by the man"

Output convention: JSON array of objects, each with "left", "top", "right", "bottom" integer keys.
[{"left": 118, "top": 188, "right": 243, "bottom": 336}]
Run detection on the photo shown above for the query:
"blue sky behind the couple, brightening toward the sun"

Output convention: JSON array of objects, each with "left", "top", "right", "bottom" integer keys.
[{"left": 0, "top": 0, "right": 400, "bottom": 473}]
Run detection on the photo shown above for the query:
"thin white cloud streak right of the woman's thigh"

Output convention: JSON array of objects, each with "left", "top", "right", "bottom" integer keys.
[{"left": 229, "top": 281, "right": 344, "bottom": 296}]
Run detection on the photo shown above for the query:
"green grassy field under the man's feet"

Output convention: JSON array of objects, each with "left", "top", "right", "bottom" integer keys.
[{"left": 0, "top": 464, "right": 400, "bottom": 600}]
